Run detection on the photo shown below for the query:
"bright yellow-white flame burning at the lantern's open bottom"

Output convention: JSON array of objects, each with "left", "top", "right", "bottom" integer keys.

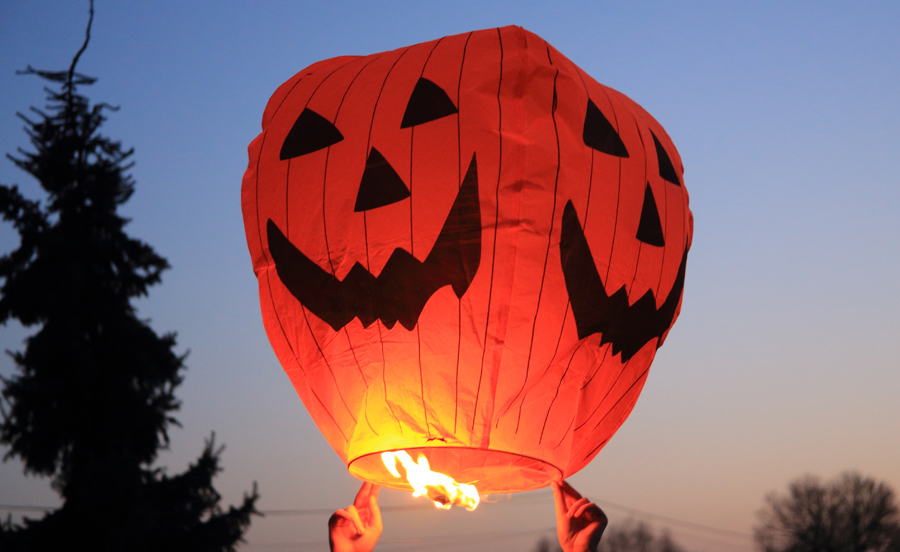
[{"left": 381, "top": 450, "right": 479, "bottom": 511}]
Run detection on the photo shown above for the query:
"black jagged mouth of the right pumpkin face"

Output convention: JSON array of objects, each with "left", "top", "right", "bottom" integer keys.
[{"left": 559, "top": 201, "right": 688, "bottom": 362}]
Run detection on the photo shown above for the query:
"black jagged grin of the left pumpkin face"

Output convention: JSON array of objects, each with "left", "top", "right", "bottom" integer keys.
[{"left": 266, "top": 154, "right": 482, "bottom": 331}]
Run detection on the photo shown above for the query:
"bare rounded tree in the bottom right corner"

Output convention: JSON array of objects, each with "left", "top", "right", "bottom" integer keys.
[{"left": 753, "top": 472, "right": 900, "bottom": 552}]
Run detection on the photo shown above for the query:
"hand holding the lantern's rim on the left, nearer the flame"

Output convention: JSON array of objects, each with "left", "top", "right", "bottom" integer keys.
[{"left": 328, "top": 482, "right": 383, "bottom": 552}]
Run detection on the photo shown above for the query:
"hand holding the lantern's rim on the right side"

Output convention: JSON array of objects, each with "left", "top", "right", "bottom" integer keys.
[{"left": 552, "top": 481, "right": 608, "bottom": 552}]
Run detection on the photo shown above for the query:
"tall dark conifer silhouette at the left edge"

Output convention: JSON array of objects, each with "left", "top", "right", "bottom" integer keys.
[{"left": 0, "top": 2, "right": 258, "bottom": 551}]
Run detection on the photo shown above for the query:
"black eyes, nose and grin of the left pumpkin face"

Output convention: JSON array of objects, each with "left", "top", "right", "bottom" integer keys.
[{"left": 266, "top": 78, "right": 481, "bottom": 331}]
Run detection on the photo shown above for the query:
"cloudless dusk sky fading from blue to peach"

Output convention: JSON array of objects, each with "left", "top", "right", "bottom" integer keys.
[{"left": 0, "top": 0, "right": 900, "bottom": 552}]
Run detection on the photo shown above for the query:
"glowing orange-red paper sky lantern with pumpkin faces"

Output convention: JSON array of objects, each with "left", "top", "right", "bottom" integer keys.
[{"left": 242, "top": 27, "right": 693, "bottom": 507}]
